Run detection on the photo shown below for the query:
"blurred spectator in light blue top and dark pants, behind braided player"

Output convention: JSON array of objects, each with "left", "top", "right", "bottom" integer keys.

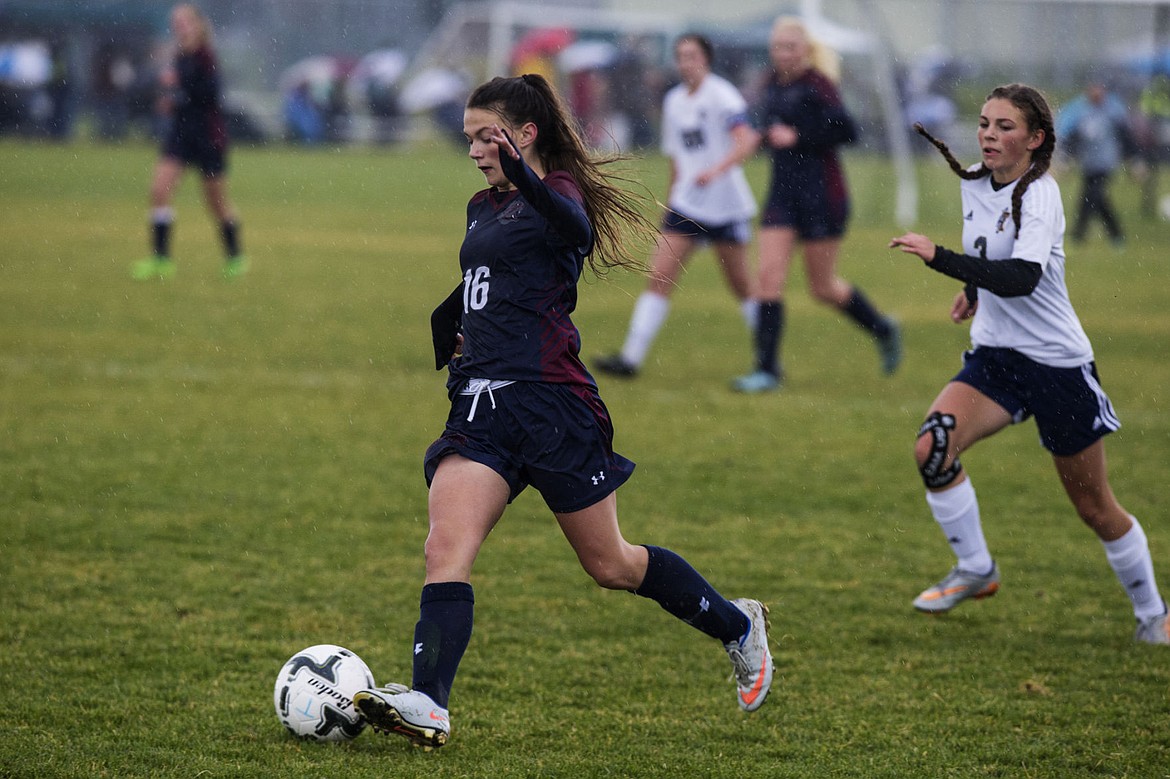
[{"left": 1055, "top": 78, "right": 1135, "bottom": 246}]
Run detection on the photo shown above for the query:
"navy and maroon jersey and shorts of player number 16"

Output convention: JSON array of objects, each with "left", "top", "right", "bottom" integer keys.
[{"left": 425, "top": 148, "right": 634, "bottom": 511}]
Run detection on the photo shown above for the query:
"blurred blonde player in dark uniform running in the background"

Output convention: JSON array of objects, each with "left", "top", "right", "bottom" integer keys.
[{"left": 732, "top": 16, "right": 902, "bottom": 393}]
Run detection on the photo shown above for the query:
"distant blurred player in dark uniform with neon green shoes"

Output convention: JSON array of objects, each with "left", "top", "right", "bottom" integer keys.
[{"left": 131, "top": 4, "right": 248, "bottom": 281}]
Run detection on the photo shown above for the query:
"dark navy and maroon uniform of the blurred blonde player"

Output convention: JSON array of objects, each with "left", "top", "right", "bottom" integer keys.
[{"left": 753, "top": 69, "right": 858, "bottom": 240}]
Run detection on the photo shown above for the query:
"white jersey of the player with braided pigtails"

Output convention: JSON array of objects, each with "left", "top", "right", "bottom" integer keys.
[{"left": 961, "top": 174, "right": 1093, "bottom": 367}]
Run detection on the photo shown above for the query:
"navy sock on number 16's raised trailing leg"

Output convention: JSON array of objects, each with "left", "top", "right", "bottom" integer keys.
[{"left": 633, "top": 546, "right": 750, "bottom": 643}]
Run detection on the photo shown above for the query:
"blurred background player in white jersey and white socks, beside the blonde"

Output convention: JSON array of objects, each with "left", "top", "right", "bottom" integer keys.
[{"left": 596, "top": 34, "right": 758, "bottom": 377}]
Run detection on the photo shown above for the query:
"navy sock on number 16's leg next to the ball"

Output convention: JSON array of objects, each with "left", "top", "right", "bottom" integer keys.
[{"left": 411, "top": 581, "right": 475, "bottom": 709}]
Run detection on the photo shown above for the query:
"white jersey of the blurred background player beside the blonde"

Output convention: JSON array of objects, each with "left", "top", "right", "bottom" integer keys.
[{"left": 662, "top": 74, "right": 756, "bottom": 226}]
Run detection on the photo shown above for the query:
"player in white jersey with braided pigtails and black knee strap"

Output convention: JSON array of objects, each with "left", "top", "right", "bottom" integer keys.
[{"left": 890, "top": 84, "right": 1170, "bottom": 643}]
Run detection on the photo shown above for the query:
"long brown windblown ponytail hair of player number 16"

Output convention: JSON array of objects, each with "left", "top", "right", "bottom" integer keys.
[{"left": 467, "top": 74, "right": 656, "bottom": 275}]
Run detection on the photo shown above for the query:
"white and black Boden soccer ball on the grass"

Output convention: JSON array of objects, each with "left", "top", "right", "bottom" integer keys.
[{"left": 273, "top": 643, "right": 374, "bottom": 742}]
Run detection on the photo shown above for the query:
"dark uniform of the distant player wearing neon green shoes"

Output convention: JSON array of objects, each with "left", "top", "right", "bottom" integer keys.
[{"left": 163, "top": 46, "right": 227, "bottom": 175}]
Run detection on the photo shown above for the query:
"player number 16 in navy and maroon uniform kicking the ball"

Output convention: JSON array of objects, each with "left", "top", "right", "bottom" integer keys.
[{"left": 353, "top": 75, "right": 772, "bottom": 746}]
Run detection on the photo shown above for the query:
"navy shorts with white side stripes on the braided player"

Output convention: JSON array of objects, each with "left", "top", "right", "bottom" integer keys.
[{"left": 955, "top": 346, "right": 1121, "bottom": 457}]
